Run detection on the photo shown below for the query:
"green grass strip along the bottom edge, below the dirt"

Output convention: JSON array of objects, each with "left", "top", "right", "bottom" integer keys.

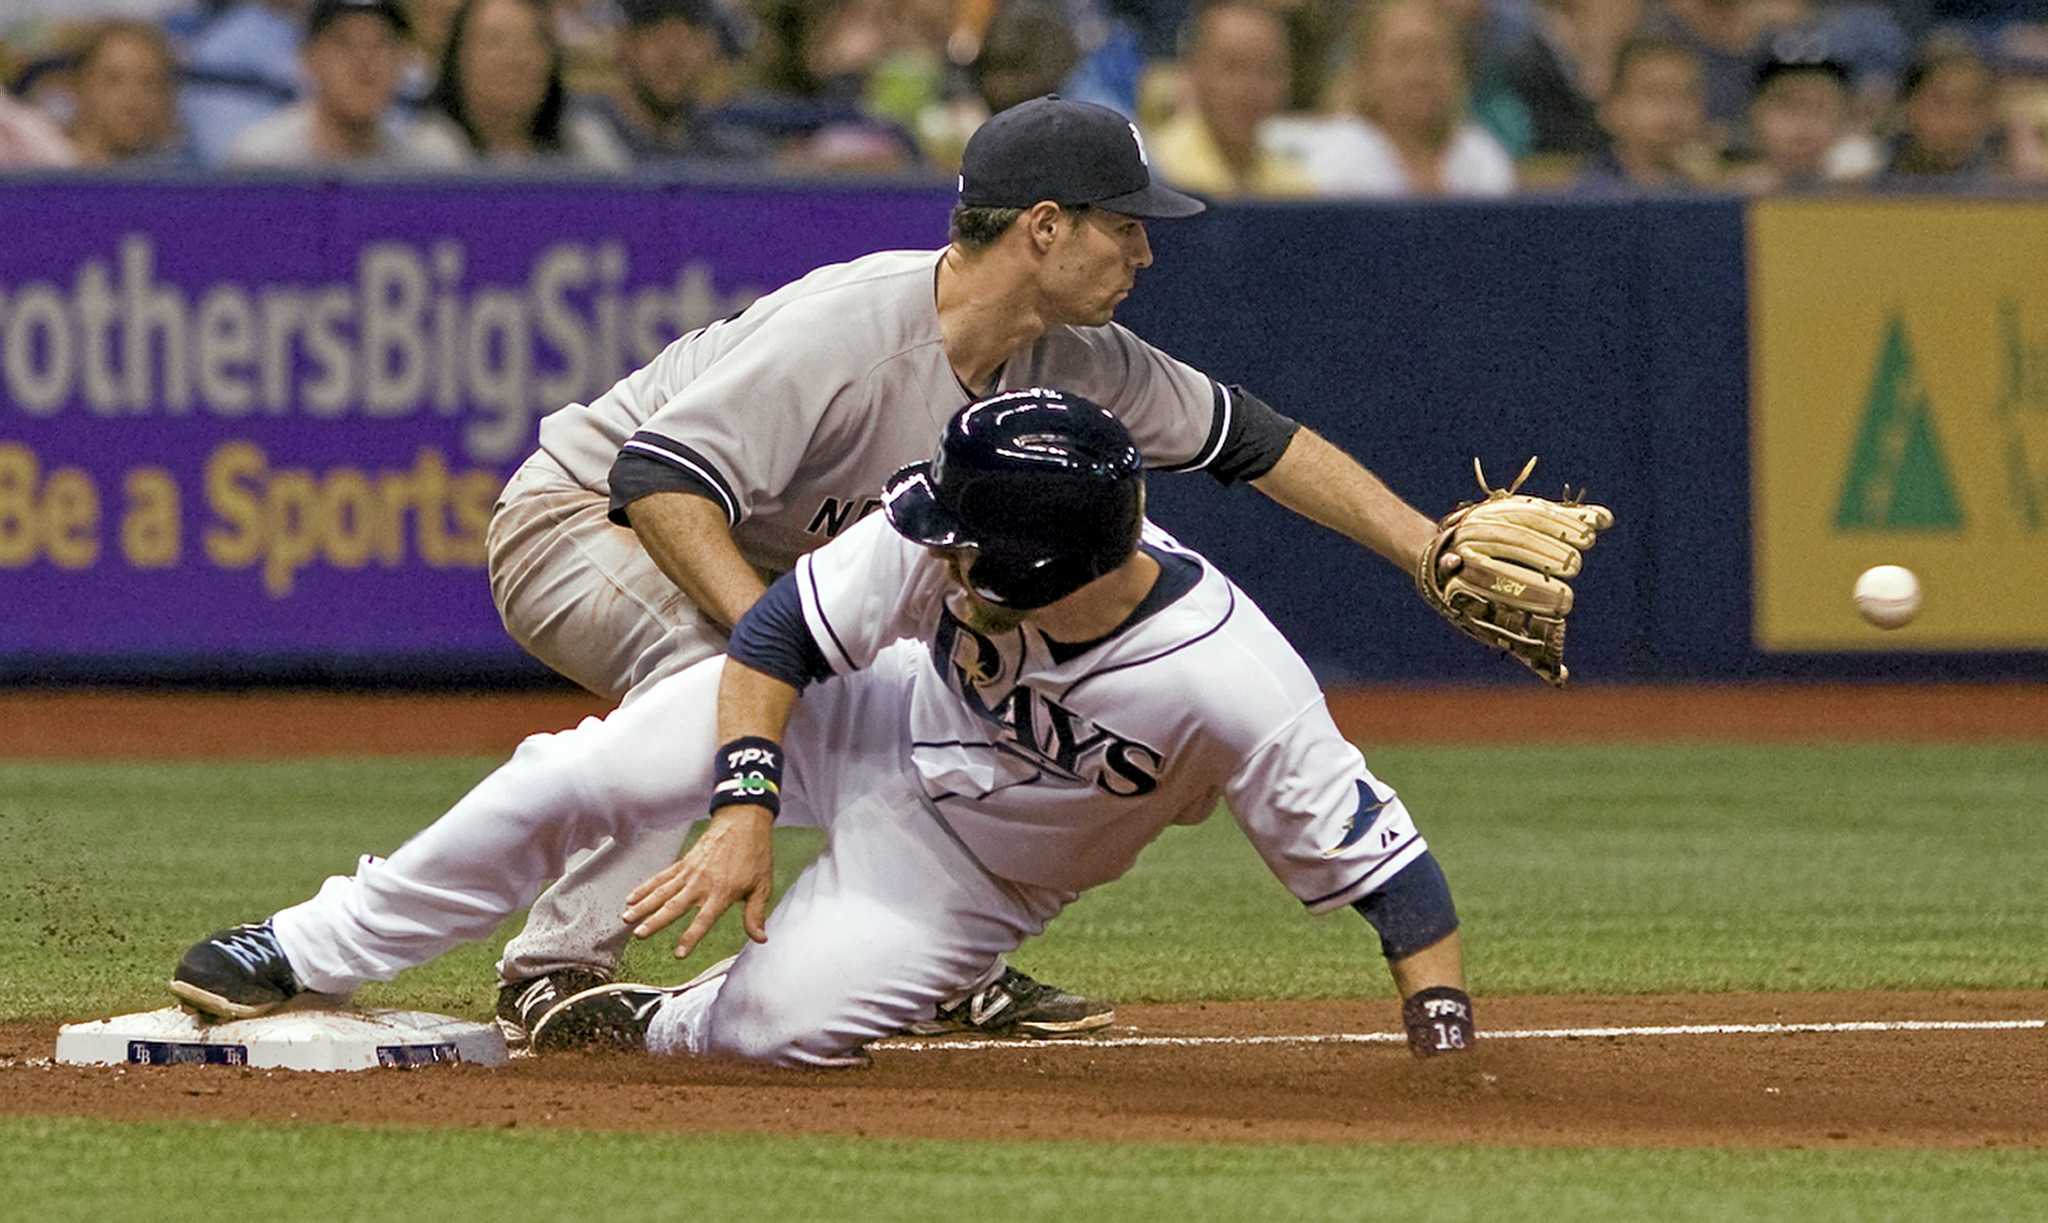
[{"left": 0, "top": 1119, "right": 2048, "bottom": 1223}]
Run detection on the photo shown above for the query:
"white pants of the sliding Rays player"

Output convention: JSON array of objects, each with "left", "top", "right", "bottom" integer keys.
[{"left": 274, "top": 641, "right": 1073, "bottom": 1065}]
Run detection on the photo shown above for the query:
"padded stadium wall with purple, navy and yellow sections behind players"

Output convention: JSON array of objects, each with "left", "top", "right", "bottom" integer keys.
[{"left": 0, "top": 180, "right": 2048, "bottom": 682}]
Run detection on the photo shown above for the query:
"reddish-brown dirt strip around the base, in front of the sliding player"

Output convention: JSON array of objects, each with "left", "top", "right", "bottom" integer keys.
[{"left": 0, "top": 992, "right": 2048, "bottom": 1149}]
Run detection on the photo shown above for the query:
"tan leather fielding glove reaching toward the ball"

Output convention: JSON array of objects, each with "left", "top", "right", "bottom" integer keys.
[{"left": 1415, "top": 459, "right": 1614, "bottom": 686}]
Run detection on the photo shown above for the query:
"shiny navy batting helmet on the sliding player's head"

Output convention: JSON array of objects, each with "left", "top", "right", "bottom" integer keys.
[{"left": 883, "top": 387, "right": 1145, "bottom": 610}]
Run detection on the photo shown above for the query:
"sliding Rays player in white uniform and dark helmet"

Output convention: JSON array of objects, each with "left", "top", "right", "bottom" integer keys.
[{"left": 159, "top": 389, "right": 1475, "bottom": 1065}]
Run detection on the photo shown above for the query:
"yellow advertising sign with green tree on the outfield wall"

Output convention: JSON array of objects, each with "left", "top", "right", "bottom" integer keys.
[{"left": 1749, "top": 201, "right": 2048, "bottom": 649}]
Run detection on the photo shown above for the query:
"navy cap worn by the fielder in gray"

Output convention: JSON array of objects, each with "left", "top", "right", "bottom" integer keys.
[{"left": 961, "top": 94, "right": 1206, "bottom": 217}]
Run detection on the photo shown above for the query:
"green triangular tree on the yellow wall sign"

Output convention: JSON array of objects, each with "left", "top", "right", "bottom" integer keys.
[{"left": 1835, "top": 313, "right": 1962, "bottom": 531}]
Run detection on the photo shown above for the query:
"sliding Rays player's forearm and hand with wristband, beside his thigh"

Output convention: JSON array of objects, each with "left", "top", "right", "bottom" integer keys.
[{"left": 625, "top": 658, "right": 797, "bottom": 959}]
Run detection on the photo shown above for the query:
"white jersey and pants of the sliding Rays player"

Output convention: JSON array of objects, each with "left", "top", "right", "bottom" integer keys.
[{"left": 274, "top": 514, "right": 1425, "bottom": 1065}]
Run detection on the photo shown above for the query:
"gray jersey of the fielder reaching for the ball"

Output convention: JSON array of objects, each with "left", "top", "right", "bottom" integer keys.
[{"left": 541, "top": 250, "right": 1294, "bottom": 572}]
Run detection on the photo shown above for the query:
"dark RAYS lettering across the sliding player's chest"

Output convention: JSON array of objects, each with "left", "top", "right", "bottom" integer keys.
[{"left": 930, "top": 608, "right": 1165, "bottom": 799}]
